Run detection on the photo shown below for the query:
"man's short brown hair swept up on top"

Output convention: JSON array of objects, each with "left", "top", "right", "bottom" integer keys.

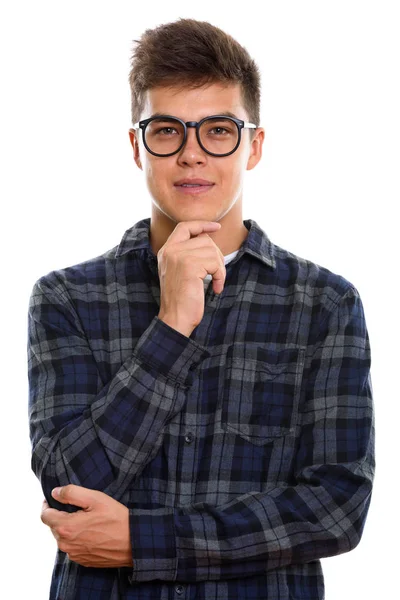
[{"left": 129, "top": 18, "right": 261, "bottom": 126}]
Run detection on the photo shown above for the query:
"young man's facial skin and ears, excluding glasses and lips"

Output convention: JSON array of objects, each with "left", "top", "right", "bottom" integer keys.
[{"left": 130, "top": 83, "right": 264, "bottom": 226}]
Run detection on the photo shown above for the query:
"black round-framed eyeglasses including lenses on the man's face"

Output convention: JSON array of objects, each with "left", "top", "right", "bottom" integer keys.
[{"left": 133, "top": 115, "right": 257, "bottom": 156}]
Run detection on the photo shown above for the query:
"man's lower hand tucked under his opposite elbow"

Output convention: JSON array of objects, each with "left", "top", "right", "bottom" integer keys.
[{"left": 41, "top": 485, "right": 133, "bottom": 568}]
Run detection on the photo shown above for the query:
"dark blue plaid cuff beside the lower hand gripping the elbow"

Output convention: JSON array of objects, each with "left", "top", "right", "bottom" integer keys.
[{"left": 128, "top": 508, "right": 178, "bottom": 583}]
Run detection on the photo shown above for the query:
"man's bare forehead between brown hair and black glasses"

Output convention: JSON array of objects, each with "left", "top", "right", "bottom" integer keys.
[{"left": 142, "top": 82, "right": 246, "bottom": 119}]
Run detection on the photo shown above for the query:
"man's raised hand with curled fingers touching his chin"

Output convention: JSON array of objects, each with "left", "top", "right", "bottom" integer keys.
[{"left": 157, "top": 221, "right": 226, "bottom": 337}]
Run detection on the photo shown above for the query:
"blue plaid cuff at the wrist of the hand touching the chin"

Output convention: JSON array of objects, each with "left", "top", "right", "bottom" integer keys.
[{"left": 134, "top": 317, "right": 211, "bottom": 386}]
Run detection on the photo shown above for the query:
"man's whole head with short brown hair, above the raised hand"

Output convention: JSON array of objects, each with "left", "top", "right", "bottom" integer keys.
[{"left": 129, "top": 19, "right": 264, "bottom": 253}]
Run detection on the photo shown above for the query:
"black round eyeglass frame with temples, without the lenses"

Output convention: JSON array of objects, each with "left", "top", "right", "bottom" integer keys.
[{"left": 132, "top": 115, "right": 257, "bottom": 157}]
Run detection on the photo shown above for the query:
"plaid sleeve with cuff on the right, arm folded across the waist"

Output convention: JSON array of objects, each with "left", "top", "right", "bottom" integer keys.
[{"left": 129, "top": 287, "right": 375, "bottom": 582}]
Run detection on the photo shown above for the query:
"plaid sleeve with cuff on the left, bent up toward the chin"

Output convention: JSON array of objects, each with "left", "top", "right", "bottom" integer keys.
[{"left": 28, "top": 276, "right": 209, "bottom": 511}]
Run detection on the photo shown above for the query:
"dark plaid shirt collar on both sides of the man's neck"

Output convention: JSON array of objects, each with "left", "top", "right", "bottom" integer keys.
[{"left": 115, "top": 217, "right": 276, "bottom": 269}]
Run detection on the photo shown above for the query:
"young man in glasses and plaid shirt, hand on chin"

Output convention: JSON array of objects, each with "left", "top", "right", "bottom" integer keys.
[{"left": 29, "top": 19, "right": 374, "bottom": 600}]
